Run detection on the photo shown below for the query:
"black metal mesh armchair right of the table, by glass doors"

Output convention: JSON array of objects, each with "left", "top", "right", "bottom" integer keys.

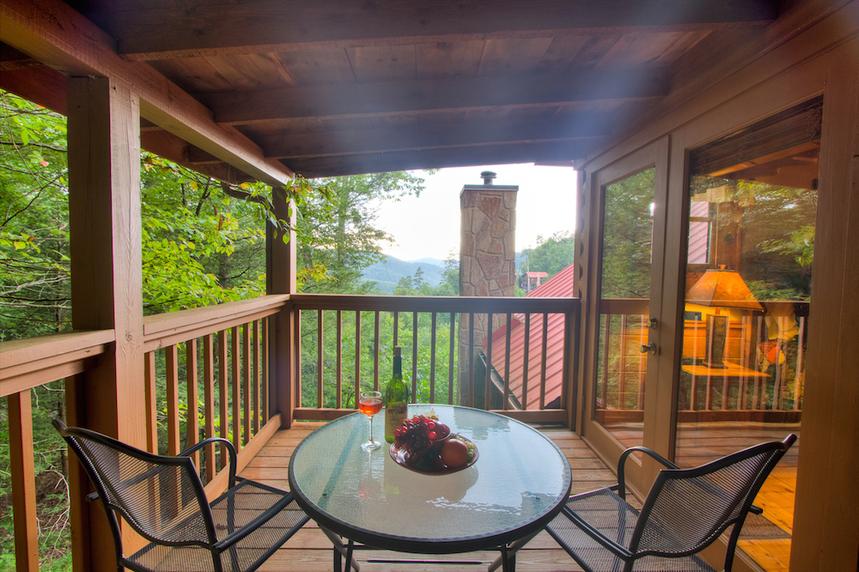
[{"left": 546, "top": 434, "right": 796, "bottom": 572}]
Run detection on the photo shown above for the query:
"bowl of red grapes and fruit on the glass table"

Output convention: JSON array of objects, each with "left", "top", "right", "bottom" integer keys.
[{"left": 389, "top": 415, "right": 478, "bottom": 474}]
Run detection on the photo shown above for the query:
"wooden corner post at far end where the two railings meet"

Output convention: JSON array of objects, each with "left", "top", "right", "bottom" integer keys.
[{"left": 266, "top": 188, "right": 298, "bottom": 428}]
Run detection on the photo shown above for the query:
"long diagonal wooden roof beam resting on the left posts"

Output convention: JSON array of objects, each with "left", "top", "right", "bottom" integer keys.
[{"left": 0, "top": 0, "right": 292, "bottom": 184}]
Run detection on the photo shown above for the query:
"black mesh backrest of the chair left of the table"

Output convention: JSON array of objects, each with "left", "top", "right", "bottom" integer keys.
[{"left": 54, "top": 420, "right": 217, "bottom": 551}]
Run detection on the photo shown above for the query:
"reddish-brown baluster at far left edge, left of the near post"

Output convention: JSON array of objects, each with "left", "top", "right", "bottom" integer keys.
[{"left": 6, "top": 389, "right": 39, "bottom": 572}]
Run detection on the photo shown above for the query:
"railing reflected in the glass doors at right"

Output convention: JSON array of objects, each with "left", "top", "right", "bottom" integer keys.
[{"left": 595, "top": 299, "right": 808, "bottom": 422}]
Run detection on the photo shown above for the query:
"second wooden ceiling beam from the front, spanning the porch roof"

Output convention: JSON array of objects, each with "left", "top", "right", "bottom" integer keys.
[{"left": 199, "top": 66, "right": 670, "bottom": 125}]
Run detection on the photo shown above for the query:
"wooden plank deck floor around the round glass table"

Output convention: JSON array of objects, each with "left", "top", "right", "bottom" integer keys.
[{"left": 241, "top": 423, "right": 615, "bottom": 572}]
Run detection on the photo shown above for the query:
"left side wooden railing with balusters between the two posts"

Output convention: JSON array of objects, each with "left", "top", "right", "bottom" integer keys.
[{"left": 144, "top": 295, "right": 289, "bottom": 494}]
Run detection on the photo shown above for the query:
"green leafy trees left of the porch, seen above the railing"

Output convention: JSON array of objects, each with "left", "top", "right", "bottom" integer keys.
[{"left": 0, "top": 91, "right": 423, "bottom": 569}]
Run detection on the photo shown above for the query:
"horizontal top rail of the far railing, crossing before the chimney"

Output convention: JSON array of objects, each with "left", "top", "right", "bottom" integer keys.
[{"left": 290, "top": 294, "right": 580, "bottom": 314}]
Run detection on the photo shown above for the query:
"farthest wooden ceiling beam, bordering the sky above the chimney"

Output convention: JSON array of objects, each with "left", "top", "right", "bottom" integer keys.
[{"left": 288, "top": 140, "right": 591, "bottom": 178}]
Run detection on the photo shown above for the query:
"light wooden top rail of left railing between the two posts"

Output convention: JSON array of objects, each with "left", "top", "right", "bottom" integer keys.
[{"left": 143, "top": 294, "right": 289, "bottom": 351}]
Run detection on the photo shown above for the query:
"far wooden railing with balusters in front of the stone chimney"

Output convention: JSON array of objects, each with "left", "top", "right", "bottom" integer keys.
[{"left": 290, "top": 294, "right": 579, "bottom": 423}]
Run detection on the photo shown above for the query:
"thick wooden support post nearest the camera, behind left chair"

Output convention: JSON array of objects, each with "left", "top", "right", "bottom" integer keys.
[{"left": 68, "top": 77, "right": 147, "bottom": 570}]
